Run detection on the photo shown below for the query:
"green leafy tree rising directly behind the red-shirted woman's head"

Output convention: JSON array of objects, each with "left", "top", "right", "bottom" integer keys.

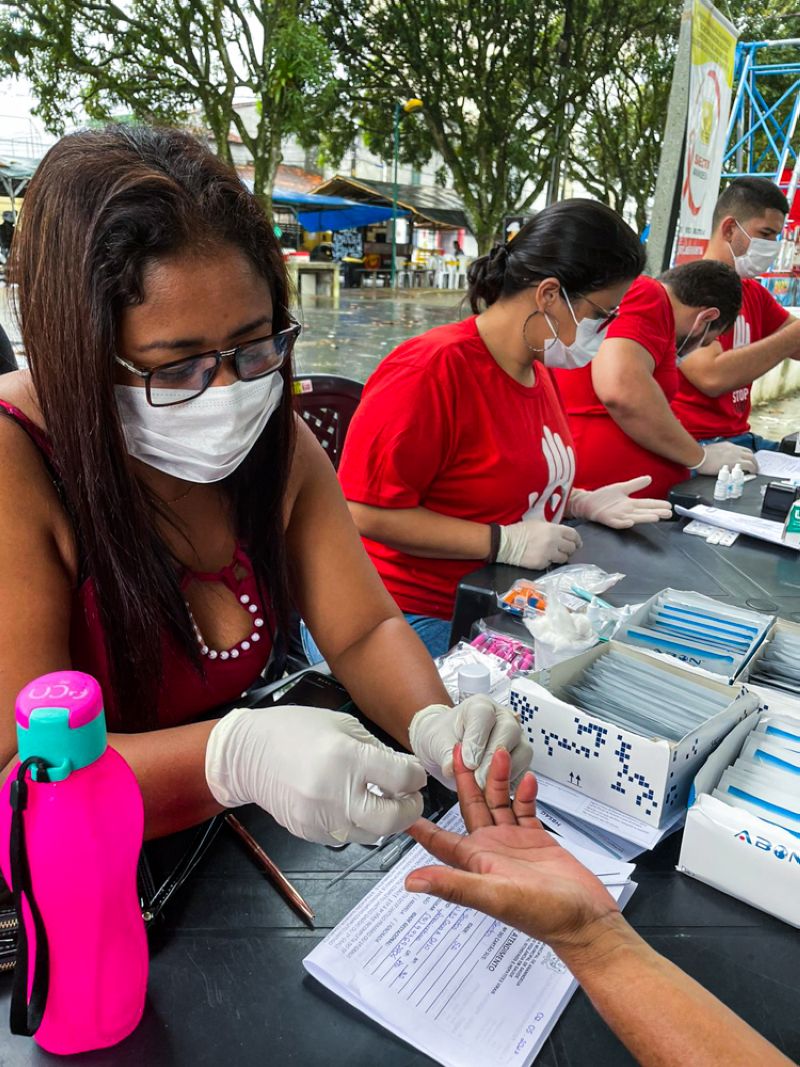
[{"left": 320, "top": 0, "right": 678, "bottom": 248}]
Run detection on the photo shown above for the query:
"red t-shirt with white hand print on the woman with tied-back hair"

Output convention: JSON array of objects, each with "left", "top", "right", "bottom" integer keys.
[{"left": 339, "top": 317, "right": 575, "bottom": 619}]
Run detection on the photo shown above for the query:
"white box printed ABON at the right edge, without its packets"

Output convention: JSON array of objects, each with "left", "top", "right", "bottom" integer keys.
[{"left": 677, "top": 702, "right": 800, "bottom": 926}]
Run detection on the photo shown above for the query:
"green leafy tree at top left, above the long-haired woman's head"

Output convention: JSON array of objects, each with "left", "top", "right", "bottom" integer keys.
[{"left": 0, "top": 0, "right": 341, "bottom": 201}]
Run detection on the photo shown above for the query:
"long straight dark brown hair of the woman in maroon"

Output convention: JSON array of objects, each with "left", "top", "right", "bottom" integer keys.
[{"left": 12, "top": 126, "right": 294, "bottom": 730}]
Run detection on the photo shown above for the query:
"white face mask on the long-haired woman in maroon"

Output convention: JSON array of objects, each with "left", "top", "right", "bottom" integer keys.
[{"left": 114, "top": 373, "right": 284, "bottom": 482}]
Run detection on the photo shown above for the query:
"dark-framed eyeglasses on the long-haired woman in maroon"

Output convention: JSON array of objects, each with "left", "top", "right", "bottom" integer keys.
[{"left": 114, "top": 317, "right": 303, "bottom": 408}]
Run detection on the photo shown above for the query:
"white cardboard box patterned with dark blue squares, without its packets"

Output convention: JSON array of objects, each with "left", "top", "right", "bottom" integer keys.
[{"left": 509, "top": 641, "right": 758, "bottom": 826}]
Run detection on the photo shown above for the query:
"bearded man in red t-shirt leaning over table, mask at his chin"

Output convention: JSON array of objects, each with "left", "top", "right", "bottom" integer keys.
[{"left": 555, "top": 260, "right": 755, "bottom": 496}]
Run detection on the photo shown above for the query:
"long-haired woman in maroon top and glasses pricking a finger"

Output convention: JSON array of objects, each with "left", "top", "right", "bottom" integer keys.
[{"left": 0, "top": 127, "right": 539, "bottom": 843}]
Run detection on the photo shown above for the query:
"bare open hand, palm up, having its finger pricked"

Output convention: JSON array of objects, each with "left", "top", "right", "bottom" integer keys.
[{"left": 405, "top": 750, "right": 619, "bottom": 952}]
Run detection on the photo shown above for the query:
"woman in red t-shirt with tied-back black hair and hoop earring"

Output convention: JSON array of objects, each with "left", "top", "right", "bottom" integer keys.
[{"left": 339, "top": 200, "right": 670, "bottom": 654}]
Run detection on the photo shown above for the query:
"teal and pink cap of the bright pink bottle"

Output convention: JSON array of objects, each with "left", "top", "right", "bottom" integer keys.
[{"left": 16, "top": 670, "right": 108, "bottom": 782}]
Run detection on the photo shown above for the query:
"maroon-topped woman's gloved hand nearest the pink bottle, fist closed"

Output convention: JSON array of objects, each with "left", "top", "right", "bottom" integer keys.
[{"left": 206, "top": 704, "right": 427, "bottom": 845}]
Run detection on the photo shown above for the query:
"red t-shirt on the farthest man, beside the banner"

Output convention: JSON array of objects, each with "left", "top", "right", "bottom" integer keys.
[{"left": 672, "top": 277, "right": 789, "bottom": 441}]
